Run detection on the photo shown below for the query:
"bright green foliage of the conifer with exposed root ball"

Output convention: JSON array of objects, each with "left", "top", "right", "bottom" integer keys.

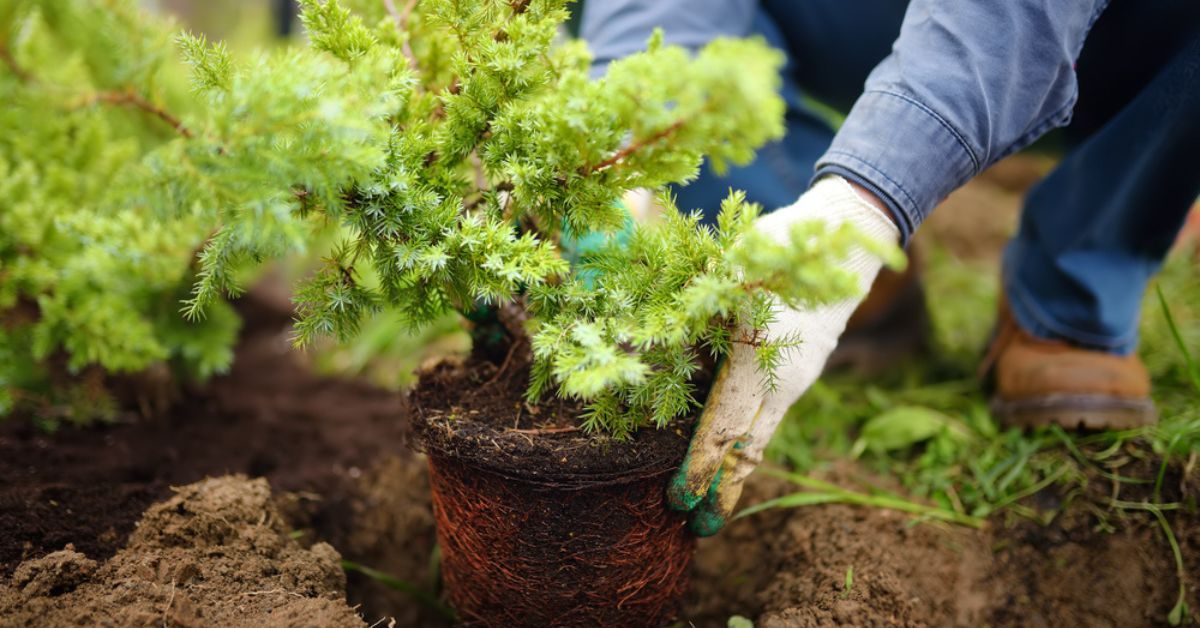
[{"left": 175, "top": 0, "right": 886, "bottom": 437}]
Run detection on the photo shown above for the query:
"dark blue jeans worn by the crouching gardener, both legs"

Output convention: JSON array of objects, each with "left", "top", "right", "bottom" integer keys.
[{"left": 677, "top": 0, "right": 1200, "bottom": 354}]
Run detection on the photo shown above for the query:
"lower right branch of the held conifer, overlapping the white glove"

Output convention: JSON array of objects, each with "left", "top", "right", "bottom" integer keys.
[{"left": 528, "top": 193, "right": 897, "bottom": 436}]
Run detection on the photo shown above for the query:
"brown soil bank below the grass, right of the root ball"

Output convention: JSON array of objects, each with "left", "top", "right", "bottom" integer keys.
[{"left": 684, "top": 463, "right": 1200, "bottom": 628}]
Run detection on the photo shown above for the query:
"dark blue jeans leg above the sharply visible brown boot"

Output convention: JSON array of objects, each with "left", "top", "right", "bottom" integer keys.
[{"left": 1004, "top": 18, "right": 1200, "bottom": 354}]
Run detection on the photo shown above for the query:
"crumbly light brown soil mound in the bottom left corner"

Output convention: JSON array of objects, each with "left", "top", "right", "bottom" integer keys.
[{"left": 0, "top": 476, "right": 364, "bottom": 627}]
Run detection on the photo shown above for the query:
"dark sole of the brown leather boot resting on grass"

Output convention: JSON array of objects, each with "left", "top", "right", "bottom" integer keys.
[{"left": 991, "top": 395, "right": 1158, "bottom": 431}]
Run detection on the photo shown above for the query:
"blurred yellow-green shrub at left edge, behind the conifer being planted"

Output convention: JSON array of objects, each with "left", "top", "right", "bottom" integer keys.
[{"left": 0, "top": 0, "right": 238, "bottom": 427}]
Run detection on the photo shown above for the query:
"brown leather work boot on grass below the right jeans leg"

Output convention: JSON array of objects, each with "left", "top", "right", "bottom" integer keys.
[{"left": 980, "top": 301, "right": 1158, "bottom": 430}]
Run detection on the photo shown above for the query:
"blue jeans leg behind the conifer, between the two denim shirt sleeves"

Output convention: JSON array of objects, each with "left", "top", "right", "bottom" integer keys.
[{"left": 673, "top": 0, "right": 907, "bottom": 223}]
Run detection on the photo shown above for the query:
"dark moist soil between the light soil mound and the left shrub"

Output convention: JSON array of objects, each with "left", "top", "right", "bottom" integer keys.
[{"left": 0, "top": 293, "right": 433, "bottom": 623}]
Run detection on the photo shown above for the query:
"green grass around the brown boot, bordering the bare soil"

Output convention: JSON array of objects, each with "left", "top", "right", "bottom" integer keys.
[{"left": 758, "top": 243, "right": 1200, "bottom": 626}]
